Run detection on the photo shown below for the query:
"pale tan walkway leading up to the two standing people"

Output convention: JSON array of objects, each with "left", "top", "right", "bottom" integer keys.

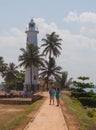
[{"left": 24, "top": 92, "right": 68, "bottom": 130}]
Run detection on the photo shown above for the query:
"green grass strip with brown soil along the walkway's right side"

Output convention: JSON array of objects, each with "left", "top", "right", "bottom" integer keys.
[{"left": 61, "top": 92, "right": 96, "bottom": 130}]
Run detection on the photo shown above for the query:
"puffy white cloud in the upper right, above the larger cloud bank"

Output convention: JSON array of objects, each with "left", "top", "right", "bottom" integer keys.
[{"left": 63, "top": 11, "right": 96, "bottom": 39}]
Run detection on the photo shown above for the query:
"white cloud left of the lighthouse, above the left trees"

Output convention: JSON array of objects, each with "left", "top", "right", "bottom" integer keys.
[{"left": 0, "top": 28, "right": 25, "bottom": 64}]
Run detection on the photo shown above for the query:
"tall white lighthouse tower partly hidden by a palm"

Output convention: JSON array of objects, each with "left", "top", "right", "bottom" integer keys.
[{"left": 24, "top": 19, "right": 39, "bottom": 92}]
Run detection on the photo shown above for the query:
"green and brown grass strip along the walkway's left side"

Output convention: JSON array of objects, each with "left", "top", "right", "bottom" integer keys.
[{"left": 0, "top": 96, "right": 44, "bottom": 130}]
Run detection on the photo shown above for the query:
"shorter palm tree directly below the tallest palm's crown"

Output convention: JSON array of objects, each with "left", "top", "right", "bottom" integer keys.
[{"left": 40, "top": 58, "right": 61, "bottom": 90}]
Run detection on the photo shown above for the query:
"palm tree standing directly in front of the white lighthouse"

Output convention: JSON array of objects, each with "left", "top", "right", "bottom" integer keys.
[{"left": 19, "top": 44, "right": 43, "bottom": 91}]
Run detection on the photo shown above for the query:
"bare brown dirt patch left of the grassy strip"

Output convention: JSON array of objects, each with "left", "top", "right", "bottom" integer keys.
[{"left": 0, "top": 104, "right": 28, "bottom": 130}]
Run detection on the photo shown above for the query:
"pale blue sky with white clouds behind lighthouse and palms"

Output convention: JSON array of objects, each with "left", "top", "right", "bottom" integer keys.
[{"left": 0, "top": 0, "right": 96, "bottom": 84}]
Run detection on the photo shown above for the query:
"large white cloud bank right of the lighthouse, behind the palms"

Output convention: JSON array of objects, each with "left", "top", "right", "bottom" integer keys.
[{"left": 37, "top": 19, "right": 96, "bottom": 82}]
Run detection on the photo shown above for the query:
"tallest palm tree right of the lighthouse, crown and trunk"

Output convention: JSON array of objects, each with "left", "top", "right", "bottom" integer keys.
[{"left": 41, "top": 32, "right": 62, "bottom": 87}]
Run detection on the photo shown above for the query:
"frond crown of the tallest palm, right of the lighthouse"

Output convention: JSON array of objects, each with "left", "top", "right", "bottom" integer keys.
[{"left": 41, "top": 32, "right": 62, "bottom": 58}]
